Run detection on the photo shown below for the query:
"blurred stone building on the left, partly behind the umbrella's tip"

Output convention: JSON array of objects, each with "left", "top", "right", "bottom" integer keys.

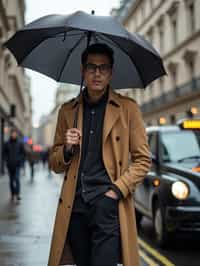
[{"left": 0, "top": 0, "right": 32, "bottom": 172}]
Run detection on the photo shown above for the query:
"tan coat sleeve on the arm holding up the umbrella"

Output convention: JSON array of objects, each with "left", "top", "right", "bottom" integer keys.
[{"left": 49, "top": 107, "right": 71, "bottom": 173}]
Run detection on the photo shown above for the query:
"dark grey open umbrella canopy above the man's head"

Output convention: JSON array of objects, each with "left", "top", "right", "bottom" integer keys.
[{"left": 5, "top": 11, "right": 166, "bottom": 89}]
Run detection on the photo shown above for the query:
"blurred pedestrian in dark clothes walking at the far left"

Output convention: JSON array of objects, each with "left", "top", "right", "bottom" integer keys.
[{"left": 4, "top": 128, "right": 25, "bottom": 202}]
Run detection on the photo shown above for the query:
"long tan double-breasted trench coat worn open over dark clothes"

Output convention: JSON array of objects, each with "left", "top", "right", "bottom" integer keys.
[{"left": 48, "top": 89, "right": 151, "bottom": 266}]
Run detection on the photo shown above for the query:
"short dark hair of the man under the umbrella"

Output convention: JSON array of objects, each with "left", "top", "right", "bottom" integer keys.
[{"left": 81, "top": 43, "right": 114, "bottom": 67}]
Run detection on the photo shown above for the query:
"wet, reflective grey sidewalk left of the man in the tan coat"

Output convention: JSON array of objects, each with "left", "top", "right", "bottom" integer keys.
[{"left": 0, "top": 165, "right": 62, "bottom": 266}]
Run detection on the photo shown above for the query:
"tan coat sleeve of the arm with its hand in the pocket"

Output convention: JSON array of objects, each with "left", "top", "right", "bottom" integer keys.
[{"left": 114, "top": 102, "right": 151, "bottom": 198}]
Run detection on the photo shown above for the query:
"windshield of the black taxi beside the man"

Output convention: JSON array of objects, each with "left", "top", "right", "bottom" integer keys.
[{"left": 161, "top": 130, "right": 200, "bottom": 162}]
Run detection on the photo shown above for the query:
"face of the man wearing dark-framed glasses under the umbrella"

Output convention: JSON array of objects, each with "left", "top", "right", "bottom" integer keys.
[{"left": 83, "top": 54, "right": 112, "bottom": 91}]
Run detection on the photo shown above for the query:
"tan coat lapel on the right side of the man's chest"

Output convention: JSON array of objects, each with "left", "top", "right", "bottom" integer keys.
[{"left": 103, "top": 89, "right": 121, "bottom": 144}]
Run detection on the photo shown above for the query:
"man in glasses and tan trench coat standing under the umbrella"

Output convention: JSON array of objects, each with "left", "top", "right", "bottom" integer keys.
[{"left": 48, "top": 44, "right": 150, "bottom": 266}]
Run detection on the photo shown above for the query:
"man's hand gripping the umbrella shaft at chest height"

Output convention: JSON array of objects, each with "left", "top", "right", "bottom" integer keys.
[{"left": 64, "top": 128, "right": 81, "bottom": 151}]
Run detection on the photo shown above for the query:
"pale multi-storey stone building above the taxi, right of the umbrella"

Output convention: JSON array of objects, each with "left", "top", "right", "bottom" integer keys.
[{"left": 112, "top": 0, "right": 200, "bottom": 125}]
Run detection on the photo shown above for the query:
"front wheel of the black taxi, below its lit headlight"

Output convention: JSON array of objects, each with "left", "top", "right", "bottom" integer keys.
[{"left": 153, "top": 202, "right": 168, "bottom": 247}]
